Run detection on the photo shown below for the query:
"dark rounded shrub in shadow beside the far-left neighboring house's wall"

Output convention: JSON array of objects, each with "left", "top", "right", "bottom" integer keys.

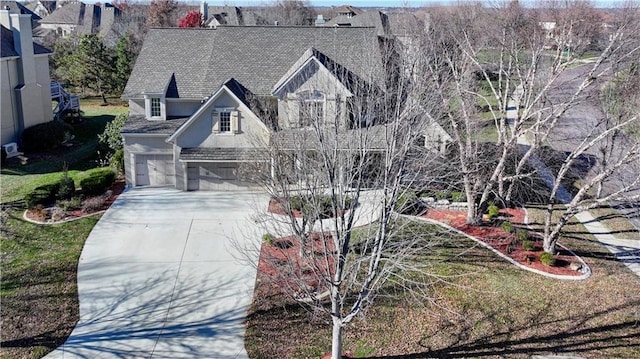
[{"left": 22, "top": 121, "right": 73, "bottom": 152}]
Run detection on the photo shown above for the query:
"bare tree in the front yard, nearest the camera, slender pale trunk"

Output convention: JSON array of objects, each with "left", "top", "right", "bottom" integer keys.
[{"left": 241, "top": 35, "right": 456, "bottom": 358}]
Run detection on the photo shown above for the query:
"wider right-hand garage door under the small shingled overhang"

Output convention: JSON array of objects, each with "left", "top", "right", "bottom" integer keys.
[{"left": 187, "top": 162, "right": 247, "bottom": 191}]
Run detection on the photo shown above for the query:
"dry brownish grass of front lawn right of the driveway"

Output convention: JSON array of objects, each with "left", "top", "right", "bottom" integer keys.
[{"left": 246, "top": 221, "right": 640, "bottom": 359}]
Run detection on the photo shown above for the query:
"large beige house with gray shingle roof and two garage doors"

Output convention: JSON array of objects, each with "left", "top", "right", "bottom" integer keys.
[{"left": 122, "top": 26, "right": 450, "bottom": 190}]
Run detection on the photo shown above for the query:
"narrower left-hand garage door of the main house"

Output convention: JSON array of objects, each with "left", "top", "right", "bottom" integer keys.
[{"left": 136, "top": 155, "right": 176, "bottom": 186}]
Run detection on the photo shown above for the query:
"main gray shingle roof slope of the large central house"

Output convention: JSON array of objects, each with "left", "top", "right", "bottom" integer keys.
[{"left": 123, "top": 26, "right": 384, "bottom": 99}]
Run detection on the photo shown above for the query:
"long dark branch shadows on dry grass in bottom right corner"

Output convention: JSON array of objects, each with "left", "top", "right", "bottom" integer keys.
[{"left": 367, "top": 301, "right": 640, "bottom": 359}]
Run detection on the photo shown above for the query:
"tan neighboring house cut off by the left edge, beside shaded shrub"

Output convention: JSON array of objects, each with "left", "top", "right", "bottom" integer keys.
[{"left": 0, "top": 10, "right": 53, "bottom": 145}]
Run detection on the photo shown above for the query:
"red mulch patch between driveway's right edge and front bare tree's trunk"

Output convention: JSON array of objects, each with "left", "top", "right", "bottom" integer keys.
[{"left": 257, "top": 232, "right": 335, "bottom": 298}]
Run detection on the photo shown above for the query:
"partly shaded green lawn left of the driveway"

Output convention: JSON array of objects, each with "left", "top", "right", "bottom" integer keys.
[{"left": 0, "top": 99, "right": 127, "bottom": 359}]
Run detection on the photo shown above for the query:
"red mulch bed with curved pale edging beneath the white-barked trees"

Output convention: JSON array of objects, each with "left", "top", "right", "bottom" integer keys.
[{"left": 423, "top": 208, "right": 582, "bottom": 276}]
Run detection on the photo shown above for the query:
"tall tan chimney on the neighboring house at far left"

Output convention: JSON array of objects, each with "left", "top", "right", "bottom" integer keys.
[{"left": 10, "top": 14, "right": 36, "bottom": 85}]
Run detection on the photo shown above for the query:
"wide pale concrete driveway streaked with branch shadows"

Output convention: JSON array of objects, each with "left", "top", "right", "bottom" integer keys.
[{"left": 46, "top": 188, "right": 267, "bottom": 358}]
